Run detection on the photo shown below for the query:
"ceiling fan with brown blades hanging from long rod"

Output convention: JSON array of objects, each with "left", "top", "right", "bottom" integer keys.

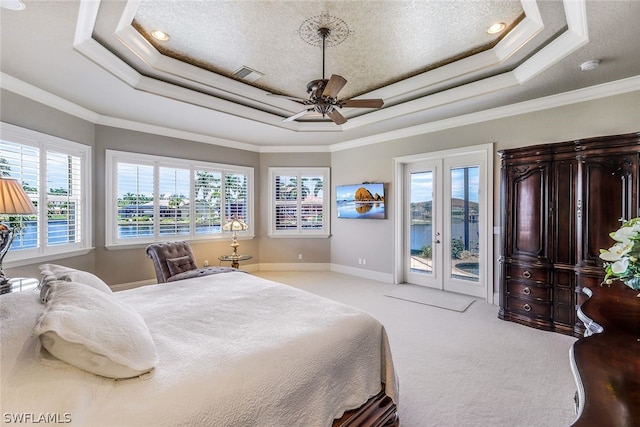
[{"left": 267, "top": 27, "right": 384, "bottom": 125}]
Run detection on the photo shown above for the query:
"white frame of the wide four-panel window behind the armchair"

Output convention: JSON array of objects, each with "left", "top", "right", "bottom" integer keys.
[{"left": 105, "top": 150, "right": 255, "bottom": 249}]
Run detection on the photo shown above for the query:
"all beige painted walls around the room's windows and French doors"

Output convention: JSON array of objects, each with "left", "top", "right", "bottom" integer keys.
[{"left": 0, "top": 86, "right": 640, "bottom": 285}]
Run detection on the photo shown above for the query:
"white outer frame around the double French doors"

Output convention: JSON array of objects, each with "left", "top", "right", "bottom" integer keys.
[{"left": 393, "top": 143, "right": 495, "bottom": 304}]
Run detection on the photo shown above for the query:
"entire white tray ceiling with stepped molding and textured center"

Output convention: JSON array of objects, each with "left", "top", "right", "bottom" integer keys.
[{"left": 2, "top": 0, "right": 640, "bottom": 149}]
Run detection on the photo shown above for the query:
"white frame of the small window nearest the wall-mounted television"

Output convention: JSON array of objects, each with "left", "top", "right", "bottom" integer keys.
[{"left": 268, "top": 167, "right": 331, "bottom": 239}]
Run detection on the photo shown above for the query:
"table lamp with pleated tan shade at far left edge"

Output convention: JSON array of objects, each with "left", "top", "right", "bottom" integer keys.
[{"left": 0, "top": 177, "right": 36, "bottom": 286}]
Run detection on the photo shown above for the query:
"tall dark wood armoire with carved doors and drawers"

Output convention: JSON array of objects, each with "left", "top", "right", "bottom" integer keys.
[{"left": 499, "top": 132, "right": 640, "bottom": 336}]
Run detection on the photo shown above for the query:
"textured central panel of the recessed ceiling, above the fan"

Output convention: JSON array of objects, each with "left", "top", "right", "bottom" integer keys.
[{"left": 134, "top": 0, "right": 524, "bottom": 98}]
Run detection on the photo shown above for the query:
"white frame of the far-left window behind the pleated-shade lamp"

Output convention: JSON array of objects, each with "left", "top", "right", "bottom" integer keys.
[{"left": 0, "top": 122, "right": 93, "bottom": 267}]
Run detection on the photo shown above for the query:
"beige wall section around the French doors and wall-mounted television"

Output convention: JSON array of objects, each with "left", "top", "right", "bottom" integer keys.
[{"left": 331, "top": 92, "right": 640, "bottom": 290}]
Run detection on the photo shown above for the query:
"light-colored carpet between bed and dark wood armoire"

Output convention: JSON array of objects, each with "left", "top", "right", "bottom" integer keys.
[{"left": 255, "top": 271, "right": 576, "bottom": 427}]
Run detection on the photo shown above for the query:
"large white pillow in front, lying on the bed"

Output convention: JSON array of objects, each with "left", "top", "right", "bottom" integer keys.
[{"left": 33, "top": 281, "right": 158, "bottom": 378}]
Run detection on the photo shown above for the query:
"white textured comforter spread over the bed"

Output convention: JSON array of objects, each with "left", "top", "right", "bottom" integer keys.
[{"left": 0, "top": 272, "right": 398, "bottom": 427}]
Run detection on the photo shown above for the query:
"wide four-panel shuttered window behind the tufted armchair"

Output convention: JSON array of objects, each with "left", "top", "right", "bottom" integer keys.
[{"left": 106, "top": 150, "right": 253, "bottom": 246}]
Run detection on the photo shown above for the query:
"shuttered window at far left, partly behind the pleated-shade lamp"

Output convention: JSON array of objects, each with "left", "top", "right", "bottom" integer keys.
[{"left": 0, "top": 123, "right": 91, "bottom": 265}]
